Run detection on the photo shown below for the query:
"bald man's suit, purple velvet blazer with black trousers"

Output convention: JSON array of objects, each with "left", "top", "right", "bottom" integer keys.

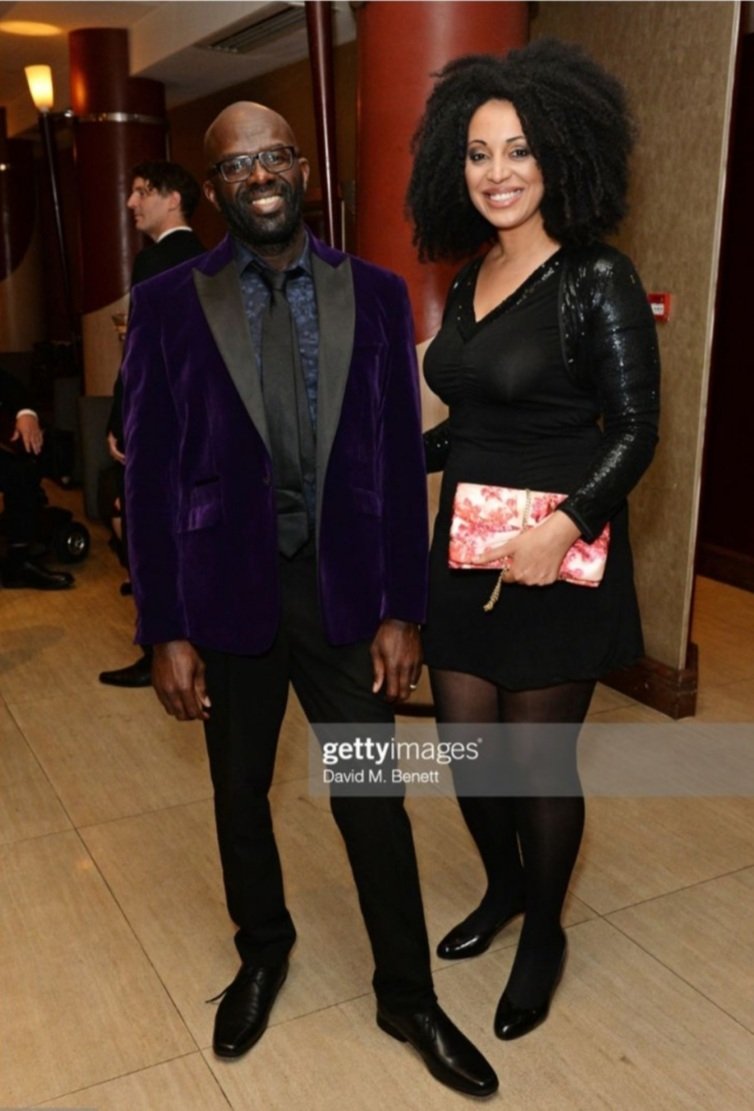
[{"left": 123, "top": 238, "right": 434, "bottom": 1012}]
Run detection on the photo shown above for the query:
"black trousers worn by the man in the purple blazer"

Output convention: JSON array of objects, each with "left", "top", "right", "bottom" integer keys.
[{"left": 201, "top": 543, "right": 435, "bottom": 1012}]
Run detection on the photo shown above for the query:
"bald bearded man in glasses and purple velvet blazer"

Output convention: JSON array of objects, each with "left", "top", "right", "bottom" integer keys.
[{"left": 123, "top": 102, "right": 497, "bottom": 1095}]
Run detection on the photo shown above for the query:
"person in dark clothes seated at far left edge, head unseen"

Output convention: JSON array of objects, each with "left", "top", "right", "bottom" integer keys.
[{"left": 0, "top": 369, "right": 73, "bottom": 590}]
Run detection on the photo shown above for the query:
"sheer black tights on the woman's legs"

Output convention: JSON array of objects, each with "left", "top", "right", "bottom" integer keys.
[{"left": 431, "top": 670, "right": 594, "bottom": 1008}]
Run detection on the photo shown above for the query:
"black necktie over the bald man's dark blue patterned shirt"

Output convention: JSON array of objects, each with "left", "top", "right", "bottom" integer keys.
[{"left": 262, "top": 270, "right": 314, "bottom": 557}]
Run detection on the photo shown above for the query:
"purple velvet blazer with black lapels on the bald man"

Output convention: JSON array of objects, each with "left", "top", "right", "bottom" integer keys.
[{"left": 123, "top": 237, "right": 428, "bottom": 654}]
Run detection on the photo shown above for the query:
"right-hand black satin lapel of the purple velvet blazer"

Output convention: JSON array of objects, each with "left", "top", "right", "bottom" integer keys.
[{"left": 312, "top": 252, "right": 356, "bottom": 521}]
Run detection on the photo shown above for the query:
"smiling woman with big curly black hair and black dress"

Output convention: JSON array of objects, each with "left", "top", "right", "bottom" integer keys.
[{"left": 408, "top": 40, "right": 659, "bottom": 1040}]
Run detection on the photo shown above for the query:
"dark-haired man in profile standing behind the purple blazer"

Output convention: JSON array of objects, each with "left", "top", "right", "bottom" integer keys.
[{"left": 99, "top": 161, "right": 204, "bottom": 687}]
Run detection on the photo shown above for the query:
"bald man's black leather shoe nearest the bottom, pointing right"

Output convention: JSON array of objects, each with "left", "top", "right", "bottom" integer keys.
[{"left": 376, "top": 1003, "right": 497, "bottom": 1095}]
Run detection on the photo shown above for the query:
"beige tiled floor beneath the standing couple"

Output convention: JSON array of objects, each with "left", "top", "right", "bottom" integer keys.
[{"left": 0, "top": 496, "right": 754, "bottom": 1111}]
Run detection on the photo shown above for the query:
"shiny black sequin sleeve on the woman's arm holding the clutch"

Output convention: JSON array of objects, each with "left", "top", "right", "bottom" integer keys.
[{"left": 560, "top": 249, "right": 660, "bottom": 540}]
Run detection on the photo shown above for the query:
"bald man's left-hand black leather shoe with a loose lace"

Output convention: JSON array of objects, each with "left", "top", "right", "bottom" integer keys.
[{"left": 212, "top": 960, "right": 288, "bottom": 1057}]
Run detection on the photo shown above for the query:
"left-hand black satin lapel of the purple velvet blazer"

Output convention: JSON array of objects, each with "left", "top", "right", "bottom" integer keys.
[{"left": 193, "top": 261, "right": 270, "bottom": 451}]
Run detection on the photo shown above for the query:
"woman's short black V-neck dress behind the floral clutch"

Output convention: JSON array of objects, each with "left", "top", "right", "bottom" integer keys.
[{"left": 424, "top": 250, "right": 643, "bottom": 690}]
